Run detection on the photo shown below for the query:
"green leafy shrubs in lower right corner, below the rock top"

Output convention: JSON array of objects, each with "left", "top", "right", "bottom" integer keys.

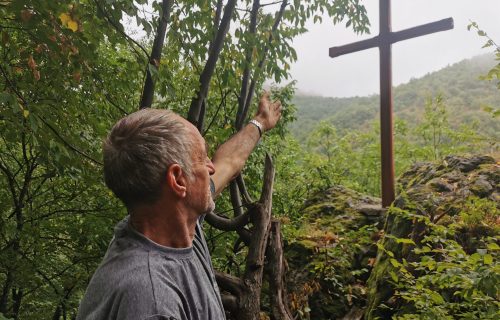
[{"left": 382, "top": 199, "right": 500, "bottom": 320}]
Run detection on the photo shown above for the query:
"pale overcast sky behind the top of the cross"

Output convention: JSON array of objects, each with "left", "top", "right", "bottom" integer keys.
[{"left": 291, "top": 0, "right": 500, "bottom": 97}]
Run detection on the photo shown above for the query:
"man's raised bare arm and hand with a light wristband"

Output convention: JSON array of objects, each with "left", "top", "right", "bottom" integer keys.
[{"left": 212, "top": 93, "right": 281, "bottom": 196}]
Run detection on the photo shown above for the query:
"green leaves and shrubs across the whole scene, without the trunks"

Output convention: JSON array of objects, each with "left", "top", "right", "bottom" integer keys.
[{"left": 0, "top": 0, "right": 500, "bottom": 319}]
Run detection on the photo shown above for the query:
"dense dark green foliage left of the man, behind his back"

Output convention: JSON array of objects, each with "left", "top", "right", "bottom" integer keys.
[{"left": 0, "top": 1, "right": 138, "bottom": 318}]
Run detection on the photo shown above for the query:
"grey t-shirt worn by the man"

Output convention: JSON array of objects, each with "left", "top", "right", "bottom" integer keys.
[{"left": 77, "top": 217, "right": 225, "bottom": 320}]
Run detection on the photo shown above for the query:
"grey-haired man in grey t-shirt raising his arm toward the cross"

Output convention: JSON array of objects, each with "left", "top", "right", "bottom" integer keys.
[{"left": 77, "top": 94, "right": 281, "bottom": 320}]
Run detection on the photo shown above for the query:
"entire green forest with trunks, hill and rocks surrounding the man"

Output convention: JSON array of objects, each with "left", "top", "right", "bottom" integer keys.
[{"left": 0, "top": 0, "right": 500, "bottom": 320}]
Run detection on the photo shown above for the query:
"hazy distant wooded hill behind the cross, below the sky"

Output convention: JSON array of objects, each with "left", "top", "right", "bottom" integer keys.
[{"left": 290, "top": 55, "right": 500, "bottom": 141}]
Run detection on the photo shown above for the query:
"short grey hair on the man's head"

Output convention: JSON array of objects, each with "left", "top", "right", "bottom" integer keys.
[{"left": 103, "top": 108, "right": 192, "bottom": 208}]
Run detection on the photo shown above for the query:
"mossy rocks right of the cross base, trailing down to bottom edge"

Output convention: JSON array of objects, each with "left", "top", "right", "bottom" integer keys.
[{"left": 365, "top": 156, "right": 500, "bottom": 319}]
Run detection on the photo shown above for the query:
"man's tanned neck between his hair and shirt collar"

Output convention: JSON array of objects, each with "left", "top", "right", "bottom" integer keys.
[{"left": 129, "top": 203, "right": 198, "bottom": 248}]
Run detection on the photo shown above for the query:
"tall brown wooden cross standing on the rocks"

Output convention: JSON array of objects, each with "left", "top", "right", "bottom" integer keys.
[{"left": 330, "top": 0, "right": 453, "bottom": 207}]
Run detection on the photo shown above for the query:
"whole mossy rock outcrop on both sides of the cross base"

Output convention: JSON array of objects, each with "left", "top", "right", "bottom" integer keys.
[{"left": 285, "top": 156, "right": 500, "bottom": 320}]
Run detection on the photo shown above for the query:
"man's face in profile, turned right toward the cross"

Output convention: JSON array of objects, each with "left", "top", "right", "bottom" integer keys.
[{"left": 187, "top": 125, "right": 215, "bottom": 214}]
